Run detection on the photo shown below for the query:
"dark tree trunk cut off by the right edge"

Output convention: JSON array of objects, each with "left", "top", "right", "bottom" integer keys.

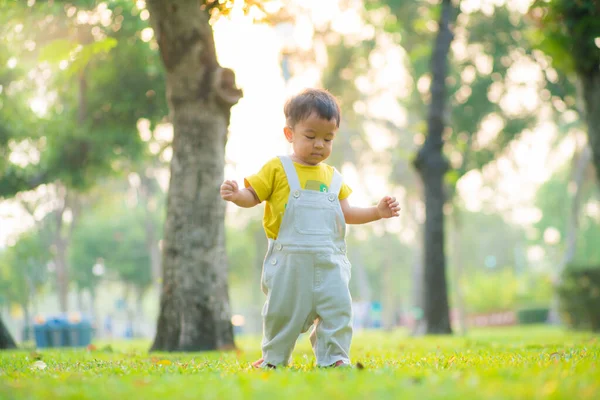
[{"left": 579, "top": 72, "right": 600, "bottom": 185}]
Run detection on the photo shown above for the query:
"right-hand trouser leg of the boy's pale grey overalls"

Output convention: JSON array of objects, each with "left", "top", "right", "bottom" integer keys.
[{"left": 310, "top": 256, "right": 352, "bottom": 367}]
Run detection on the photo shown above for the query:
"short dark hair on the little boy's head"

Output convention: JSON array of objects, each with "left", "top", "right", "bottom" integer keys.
[{"left": 283, "top": 89, "right": 342, "bottom": 128}]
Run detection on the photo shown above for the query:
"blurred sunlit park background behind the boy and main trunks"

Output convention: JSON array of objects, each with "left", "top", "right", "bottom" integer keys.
[{"left": 0, "top": 0, "right": 600, "bottom": 342}]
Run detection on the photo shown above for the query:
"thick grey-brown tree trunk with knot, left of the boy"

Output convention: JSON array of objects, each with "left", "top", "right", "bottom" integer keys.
[{"left": 147, "top": 0, "right": 241, "bottom": 351}]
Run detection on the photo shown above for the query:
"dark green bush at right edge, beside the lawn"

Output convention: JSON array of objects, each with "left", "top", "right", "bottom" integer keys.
[{"left": 558, "top": 266, "right": 600, "bottom": 331}]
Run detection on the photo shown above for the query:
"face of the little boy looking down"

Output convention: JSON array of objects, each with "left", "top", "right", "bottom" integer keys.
[{"left": 284, "top": 113, "right": 337, "bottom": 165}]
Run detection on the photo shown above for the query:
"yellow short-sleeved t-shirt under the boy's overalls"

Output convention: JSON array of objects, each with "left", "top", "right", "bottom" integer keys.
[{"left": 244, "top": 157, "right": 352, "bottom": 239}]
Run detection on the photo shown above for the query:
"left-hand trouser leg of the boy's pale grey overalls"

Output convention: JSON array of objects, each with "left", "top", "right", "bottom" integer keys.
[{"left": 261, "top": 254, "right": 315, "bottom": 366}]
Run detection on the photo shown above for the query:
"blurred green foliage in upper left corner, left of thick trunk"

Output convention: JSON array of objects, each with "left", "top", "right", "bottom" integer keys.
[{"left": 0, "top": 0, "right": 167, "bottom": 197}]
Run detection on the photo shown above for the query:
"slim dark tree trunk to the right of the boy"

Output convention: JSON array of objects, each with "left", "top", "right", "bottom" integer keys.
[{"left": 414, "top": 0, "right": 454, "bottom": 334}]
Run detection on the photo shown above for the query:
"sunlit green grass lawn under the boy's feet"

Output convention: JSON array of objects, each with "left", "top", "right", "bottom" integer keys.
[{"left": 0, "top": 327, "right": 600, "bottom": 400}]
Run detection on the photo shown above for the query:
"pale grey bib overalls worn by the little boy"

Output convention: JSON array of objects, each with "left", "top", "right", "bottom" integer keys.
[{"left": 261, "top": 157, "right": 352, "bottom": 366}]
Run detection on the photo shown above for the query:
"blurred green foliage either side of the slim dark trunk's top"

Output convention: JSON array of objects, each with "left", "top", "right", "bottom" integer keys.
[{"left": 366, "top": 0, "right": 538, "bottom": 198}]
